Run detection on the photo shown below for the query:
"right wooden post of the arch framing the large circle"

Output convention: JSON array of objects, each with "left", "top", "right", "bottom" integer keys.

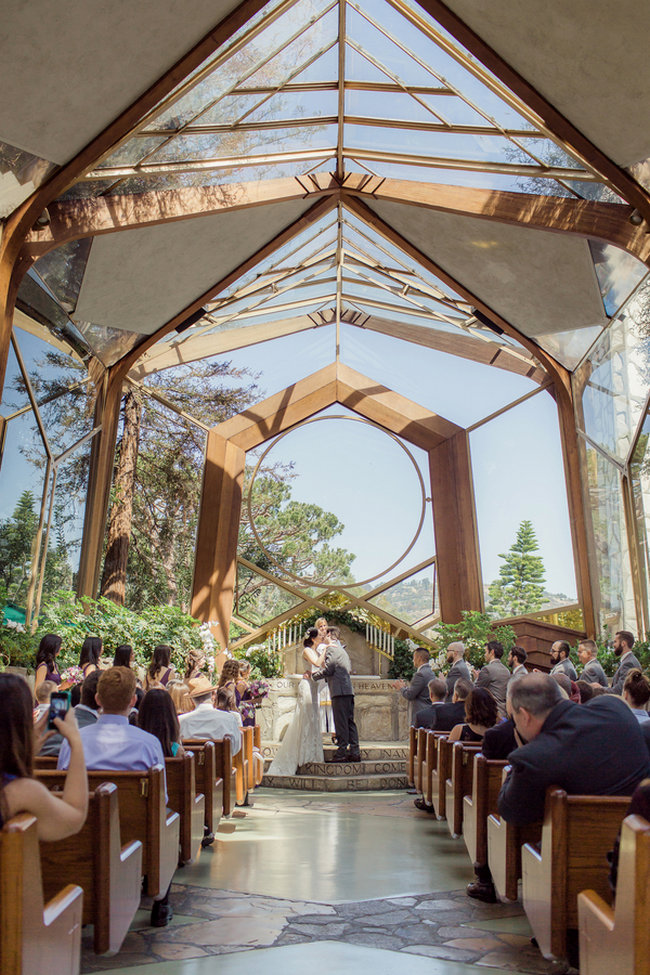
[{"left": 429, "top": 430, "right": 483, "bottom": 623}]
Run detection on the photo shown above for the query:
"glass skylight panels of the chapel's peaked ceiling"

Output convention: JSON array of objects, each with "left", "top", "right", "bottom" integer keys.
[{"left": 23, "top": 0, "right": 641, "bottom": 371}]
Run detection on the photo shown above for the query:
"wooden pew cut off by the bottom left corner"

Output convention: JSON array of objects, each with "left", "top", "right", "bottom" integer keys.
[{"left": 0, "top": 813, "right": 83, "bottom": 975}]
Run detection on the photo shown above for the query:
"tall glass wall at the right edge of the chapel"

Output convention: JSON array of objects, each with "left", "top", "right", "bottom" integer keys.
[{"left": 573, "top": 277, "right": 650, "bottom": 637}]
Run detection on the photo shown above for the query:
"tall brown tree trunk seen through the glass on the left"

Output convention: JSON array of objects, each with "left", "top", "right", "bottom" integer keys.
[{"left": 101, "top": 389, "right": 142, "bottom": 606}]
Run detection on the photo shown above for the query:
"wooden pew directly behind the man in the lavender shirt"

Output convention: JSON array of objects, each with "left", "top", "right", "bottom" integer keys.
[{"left": 36, "top": 765, "right": 180, "bottom": 897}]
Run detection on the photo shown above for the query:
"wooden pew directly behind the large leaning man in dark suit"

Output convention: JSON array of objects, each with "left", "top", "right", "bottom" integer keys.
[{"left": 521, "top": 788, "right": 630, "bottom": 958}]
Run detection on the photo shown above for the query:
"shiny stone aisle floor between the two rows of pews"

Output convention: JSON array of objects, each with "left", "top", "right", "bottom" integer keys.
[{"left": 82, "top": 789, "right": 553, "bottom": 975}]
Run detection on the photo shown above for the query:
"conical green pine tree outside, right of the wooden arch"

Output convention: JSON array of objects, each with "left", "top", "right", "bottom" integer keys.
[{"left": 488, "top": 521, "right": 545, "bottom": 617}]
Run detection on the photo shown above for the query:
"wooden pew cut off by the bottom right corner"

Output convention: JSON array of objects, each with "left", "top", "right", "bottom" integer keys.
[{"left": 578, "top": 816, "right": 650, "bottom": 975}]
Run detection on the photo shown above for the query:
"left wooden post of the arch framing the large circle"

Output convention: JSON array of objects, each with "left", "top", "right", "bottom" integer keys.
[{"left": 192, "top": 430, "right": 246, "bottom": 647}]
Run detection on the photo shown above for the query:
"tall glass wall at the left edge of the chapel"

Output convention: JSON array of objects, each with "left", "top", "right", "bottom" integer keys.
[{"left": 0, "top": 324, "right": 97, "bottom": 622}]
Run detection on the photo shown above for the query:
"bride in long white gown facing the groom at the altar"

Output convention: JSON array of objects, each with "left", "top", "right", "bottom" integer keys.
[{"left": 267, "top": 626, "right": 326, "bottom": 775}]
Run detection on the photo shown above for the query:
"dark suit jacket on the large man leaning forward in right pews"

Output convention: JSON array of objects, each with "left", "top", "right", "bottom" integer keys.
[{"left": 499, "top": 695, "right": 650, "bottom": 824}]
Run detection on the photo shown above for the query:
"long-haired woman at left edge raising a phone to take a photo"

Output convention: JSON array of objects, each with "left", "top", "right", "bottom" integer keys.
[{"left": 0, "top": 674, "right": 88, "bottom": 840}]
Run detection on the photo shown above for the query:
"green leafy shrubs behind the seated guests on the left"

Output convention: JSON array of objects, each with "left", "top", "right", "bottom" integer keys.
[{"left": 32, "top": 591, "right": 204, "bottom": 672}]
